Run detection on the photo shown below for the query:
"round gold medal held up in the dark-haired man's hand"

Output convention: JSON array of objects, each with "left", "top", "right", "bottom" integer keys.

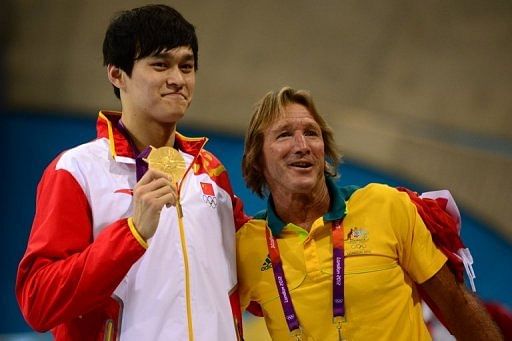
[{"left": 144, "top": 146, "right": 186, "bottom": 183}]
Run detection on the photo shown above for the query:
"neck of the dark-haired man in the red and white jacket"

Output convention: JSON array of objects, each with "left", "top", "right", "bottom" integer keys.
[{"left": 122, "top": 115, "right": 176, "bottom": 151}]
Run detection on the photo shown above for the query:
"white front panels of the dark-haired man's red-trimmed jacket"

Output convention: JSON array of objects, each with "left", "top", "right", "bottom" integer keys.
[{"left": 57, "top": 138, "right": 237, "bottom": 341}]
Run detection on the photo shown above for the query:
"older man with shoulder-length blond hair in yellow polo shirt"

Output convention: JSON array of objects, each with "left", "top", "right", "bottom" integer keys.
[{"left": 237, "top": 88, "right": 501, "bottom": 340}]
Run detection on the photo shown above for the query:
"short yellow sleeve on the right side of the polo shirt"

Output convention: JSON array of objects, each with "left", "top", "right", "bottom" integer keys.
[{"left": 395, "top": 193, "right": 446, "bottom": 284}]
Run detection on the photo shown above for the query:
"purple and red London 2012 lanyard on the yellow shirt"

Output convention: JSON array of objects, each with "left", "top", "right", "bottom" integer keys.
[{"left": 265, "top": 219, "right": 345, "bottom": 340}]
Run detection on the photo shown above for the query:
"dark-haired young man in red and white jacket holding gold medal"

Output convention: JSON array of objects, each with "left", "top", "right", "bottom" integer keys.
[{"left": 16, "top": 5, "right": 245, "bottom": 340}]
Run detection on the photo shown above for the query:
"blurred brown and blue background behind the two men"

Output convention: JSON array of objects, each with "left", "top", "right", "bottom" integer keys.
[{"left": 0, "top": 0, "right": 512, "bottom": 341}]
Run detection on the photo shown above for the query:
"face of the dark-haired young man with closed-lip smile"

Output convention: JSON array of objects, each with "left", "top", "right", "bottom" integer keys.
[{"left": 121, "top": 47, "right": 196, "bottom": 124}]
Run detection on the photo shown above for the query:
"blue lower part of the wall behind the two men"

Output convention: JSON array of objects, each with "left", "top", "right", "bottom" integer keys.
[{"left": 0, "top": 112, "right": 512, "bottom": 332}]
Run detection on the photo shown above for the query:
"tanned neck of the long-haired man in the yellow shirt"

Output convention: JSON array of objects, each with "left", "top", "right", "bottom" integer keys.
[{"left": 272, "top": 181, "right": 330, "bottom": 231}]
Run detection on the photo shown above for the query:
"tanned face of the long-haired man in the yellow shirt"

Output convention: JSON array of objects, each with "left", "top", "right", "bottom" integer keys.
[{"left": 262, "top": 103, "right": 325, "bottom": 197}]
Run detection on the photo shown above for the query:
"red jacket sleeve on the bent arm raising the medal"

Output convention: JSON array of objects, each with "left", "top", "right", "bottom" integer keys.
[{"left": 16, "top": 159, "right": 145, "bottom": 331}]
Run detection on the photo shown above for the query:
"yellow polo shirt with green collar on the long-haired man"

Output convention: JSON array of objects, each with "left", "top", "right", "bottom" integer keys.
[{"left": 237, "top": 179, "right": 446, "bottom": 341}]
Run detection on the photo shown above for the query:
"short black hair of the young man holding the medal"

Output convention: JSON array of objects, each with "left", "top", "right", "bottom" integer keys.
[{"left": 103, "top": 5, "right": 198, "bottom": 98}]
